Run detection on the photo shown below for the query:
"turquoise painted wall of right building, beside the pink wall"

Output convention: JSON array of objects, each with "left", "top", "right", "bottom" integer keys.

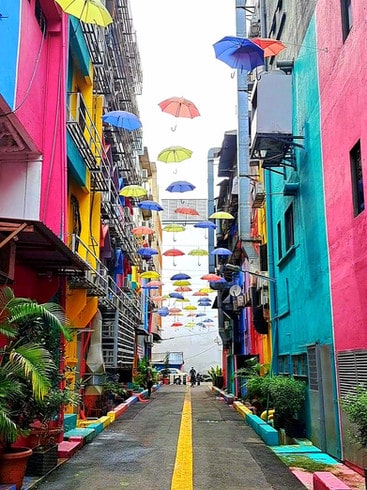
[{"left": 265, "top": 18, "right": 340, "bottom": 456}]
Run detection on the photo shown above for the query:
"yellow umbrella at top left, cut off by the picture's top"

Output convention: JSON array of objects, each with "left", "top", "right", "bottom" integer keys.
[{"left": 56, "top": 0, "right": 113, "bottom": 27}]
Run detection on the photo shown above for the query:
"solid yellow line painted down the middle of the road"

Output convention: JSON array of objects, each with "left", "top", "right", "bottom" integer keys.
[{"left": 171, "top": 387, "right": 193, "bottom": 490}]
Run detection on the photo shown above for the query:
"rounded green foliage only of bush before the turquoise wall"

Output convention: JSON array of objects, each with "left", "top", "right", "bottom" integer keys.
[{"left": 268, "top": 376, "right": 306, "bottom": 419}]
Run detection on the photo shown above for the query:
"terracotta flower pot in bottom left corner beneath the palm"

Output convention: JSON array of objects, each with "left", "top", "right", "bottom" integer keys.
[{"left": 0, "top": 447, "right": 32, "bottom": 490}]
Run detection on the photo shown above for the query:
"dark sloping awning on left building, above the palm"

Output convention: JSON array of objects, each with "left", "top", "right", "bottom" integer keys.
[{"left": 0, "top": 218, "right": 88, "bottom": 271}]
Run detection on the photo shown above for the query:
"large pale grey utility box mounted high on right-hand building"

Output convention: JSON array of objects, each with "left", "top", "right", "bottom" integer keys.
[{"left": 251, "top": 70, "right": 292, "bottom": 153}]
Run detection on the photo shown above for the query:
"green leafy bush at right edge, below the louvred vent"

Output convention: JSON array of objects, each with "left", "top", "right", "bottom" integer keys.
[{"left": 341, "top": 385, "right": 367, "bottom": 447}]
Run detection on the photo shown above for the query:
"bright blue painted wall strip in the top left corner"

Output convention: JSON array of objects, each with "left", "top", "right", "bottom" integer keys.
[{"left": 0, "top": 0, "right": 20, "bottom": 109}]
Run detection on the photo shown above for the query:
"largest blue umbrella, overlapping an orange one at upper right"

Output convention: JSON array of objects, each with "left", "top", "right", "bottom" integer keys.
[{"left": 213, "top": 36, "right": 265, "bottom": 71}]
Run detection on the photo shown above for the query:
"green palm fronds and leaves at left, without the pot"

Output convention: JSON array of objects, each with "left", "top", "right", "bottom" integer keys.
[{"left": 0, "top": 287, "right": 73, "bottom": 446}]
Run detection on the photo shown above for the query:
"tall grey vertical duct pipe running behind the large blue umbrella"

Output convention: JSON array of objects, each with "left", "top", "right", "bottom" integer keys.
[{"left": 236, "top": 0, "right": 258, "bottom": 264}]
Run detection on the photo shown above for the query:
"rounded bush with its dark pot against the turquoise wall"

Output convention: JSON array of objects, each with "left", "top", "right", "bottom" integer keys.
[{"left": 268, "top": 375, "right": 306, "bottom": 437}]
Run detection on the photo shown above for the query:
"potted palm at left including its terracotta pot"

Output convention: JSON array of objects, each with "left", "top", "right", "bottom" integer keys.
[{"left": 0, "top": 287, "right": 73, "bottom": 490}]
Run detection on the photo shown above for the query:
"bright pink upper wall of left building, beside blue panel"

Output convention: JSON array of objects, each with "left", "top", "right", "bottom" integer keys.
[{"left": 16, "top": 0, "right": 68, "bottom": 239}]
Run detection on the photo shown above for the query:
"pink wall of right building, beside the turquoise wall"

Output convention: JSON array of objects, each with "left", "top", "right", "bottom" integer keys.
[{"left": 311, "top": 0, "right": 367, "bottom": 352}]
